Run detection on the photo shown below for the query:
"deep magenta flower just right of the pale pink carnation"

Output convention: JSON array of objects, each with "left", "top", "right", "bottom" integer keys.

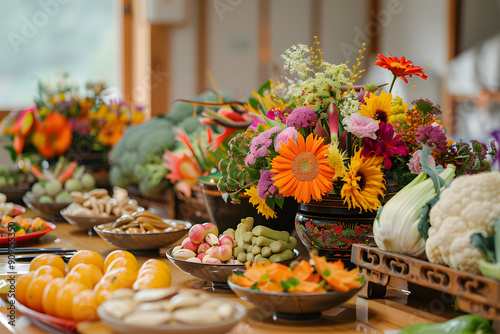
[{"left": 361, "top": 122, "right": 408, "bottom": 169}]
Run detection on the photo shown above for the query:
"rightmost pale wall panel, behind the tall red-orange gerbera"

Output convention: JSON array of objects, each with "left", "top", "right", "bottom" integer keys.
[{"left": 366, "top": 0, "right": 448, "bottom": 103}]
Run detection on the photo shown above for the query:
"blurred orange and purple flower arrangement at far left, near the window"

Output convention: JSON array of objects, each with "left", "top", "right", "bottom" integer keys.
[{"left": 2, "top": 76, "right": 144, "bottom": 160}]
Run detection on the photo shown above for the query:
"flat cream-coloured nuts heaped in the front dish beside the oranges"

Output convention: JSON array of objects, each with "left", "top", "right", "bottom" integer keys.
[{"left": 101, "top": 288, "right": 238, "bottom": 327}]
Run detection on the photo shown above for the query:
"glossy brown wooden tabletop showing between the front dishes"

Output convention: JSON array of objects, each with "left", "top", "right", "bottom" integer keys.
[{"left": 0, "top": 215, "right": 453, "bottom": 334}]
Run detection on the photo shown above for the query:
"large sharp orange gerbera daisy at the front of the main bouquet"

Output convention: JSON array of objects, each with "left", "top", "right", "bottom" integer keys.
[{"left": 271, "top": 133, "right": 335, "bottom": 203}]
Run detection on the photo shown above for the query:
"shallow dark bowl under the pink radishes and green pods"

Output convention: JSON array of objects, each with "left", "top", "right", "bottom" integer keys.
[{"left": 167, "top": 248, "right": 299, "bottom": 288}]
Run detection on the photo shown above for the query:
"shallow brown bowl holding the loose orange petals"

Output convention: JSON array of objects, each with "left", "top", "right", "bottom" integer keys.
[{"left": 227, "top": 279, "right": 362, "bottom": 320}]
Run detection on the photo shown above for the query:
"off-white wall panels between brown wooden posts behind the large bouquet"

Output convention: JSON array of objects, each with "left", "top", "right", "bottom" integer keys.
[{"left": 165, "top": 0, "right": 448, "bottom": 103}]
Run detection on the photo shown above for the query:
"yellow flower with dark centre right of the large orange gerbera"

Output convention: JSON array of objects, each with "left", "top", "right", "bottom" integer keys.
[{"left": 340, "top": 149, "right": 385, "bottom": 211}]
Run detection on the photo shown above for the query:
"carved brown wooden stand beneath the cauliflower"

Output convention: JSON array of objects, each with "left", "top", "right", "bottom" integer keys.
[{"left": 351, "top": 244, "right": 500, "bottom": 321}]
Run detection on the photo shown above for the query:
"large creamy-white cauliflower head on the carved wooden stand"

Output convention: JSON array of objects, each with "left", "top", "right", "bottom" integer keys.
[{"left": 425, "top": 172, "right": 500, "bottom": 273}]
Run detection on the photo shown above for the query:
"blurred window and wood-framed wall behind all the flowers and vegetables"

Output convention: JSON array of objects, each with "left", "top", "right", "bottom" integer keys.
[{"left": 0, "top": 0, "right": 500, "bottom": 152}]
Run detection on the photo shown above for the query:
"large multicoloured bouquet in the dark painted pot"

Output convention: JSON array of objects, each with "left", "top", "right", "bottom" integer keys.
[{"left": 218, "top": 38, "right": 497, "bottom": 218}]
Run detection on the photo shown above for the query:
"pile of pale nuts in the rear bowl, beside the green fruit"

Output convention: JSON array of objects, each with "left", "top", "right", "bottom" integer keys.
[{"left": 65, "top": 187, "right": 139, "bottom": 217}]
